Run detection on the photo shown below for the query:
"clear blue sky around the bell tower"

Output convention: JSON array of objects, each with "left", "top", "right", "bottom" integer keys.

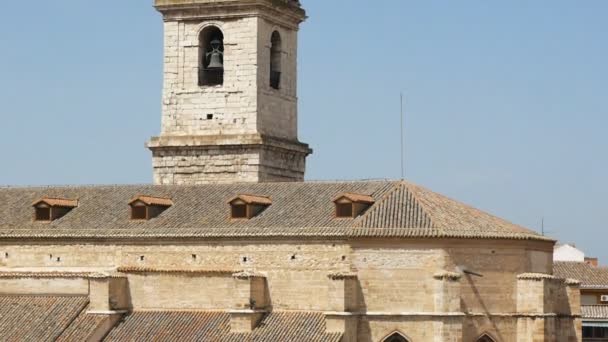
[{"left": 0, "top": 0, "right": 608, "bottom": 264}]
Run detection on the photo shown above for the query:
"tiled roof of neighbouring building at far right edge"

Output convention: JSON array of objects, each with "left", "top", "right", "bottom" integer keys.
[{"left": 553, "top": 261, "right": 608, "bottom": 289}]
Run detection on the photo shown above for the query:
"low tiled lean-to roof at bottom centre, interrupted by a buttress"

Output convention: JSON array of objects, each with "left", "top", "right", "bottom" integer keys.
[{"left": 104, "top": 311, "right": 342, "bottom": 342}]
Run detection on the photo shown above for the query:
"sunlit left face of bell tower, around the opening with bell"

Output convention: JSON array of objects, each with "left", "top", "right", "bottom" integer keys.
[{"left": 161, "top": 17, "right": 258, "bottom": 135}]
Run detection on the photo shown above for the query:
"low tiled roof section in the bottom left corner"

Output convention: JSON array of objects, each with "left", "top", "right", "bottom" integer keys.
[{"left": 0, "top": 295, "right": 88, "bottom": 341}]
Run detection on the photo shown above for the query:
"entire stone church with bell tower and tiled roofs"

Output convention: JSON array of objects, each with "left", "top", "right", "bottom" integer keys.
[{"left": 0, "top": 0, "right": 581, "bottom": 342}]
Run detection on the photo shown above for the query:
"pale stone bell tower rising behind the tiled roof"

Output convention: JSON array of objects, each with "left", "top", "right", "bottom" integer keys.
[{"left": 147, "top": 0, "right": 312, "bottom": 184}]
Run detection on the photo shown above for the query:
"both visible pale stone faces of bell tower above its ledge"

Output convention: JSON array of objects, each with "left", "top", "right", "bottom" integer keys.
[{"left": 161, "top": 17, "right": 297, "bottom": 140}]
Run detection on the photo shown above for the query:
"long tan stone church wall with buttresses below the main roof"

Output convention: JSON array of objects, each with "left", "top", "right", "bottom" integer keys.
[{"left": 0, "top": 239, "right": 580, "bottom": 342}]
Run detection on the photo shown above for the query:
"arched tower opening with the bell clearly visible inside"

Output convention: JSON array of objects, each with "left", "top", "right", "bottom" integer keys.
[{"left": 198, "top": 26, "right": 224, "bottom": 86}]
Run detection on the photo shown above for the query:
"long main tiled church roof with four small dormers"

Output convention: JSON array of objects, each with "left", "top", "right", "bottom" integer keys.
[{"left": 0, "top": 181, "right": 552, "bottom": 241}]
